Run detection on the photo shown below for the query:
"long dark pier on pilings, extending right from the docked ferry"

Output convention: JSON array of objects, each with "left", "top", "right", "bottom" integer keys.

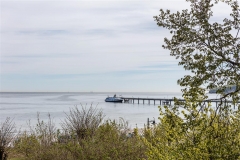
[{"left": 120, "top": 97, "right": 240, "bottom": 108}]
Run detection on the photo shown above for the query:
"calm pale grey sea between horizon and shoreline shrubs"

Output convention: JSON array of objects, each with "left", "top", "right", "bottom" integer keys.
[{"left": 0, "top": 92, "right": 186, "bottom": 130}]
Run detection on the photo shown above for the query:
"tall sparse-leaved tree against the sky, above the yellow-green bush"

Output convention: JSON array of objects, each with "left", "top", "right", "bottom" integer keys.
[{"left": 154, "top": 0, "right": 240, "bottom": 101}]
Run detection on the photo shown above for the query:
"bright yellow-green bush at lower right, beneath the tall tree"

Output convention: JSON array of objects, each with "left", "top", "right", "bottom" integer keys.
[{"left": 143, "top": 103, "right": 240, "bottom": 159}]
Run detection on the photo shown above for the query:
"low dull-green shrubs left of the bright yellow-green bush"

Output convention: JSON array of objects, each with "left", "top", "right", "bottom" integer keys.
[{"left": 8, "top": 108, "right": 146, "bottom": 160}]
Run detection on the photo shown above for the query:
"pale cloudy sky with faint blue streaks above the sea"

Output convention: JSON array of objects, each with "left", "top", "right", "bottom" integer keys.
[{"left": 0, "top": 0, "right": 232, "bottom": 92}]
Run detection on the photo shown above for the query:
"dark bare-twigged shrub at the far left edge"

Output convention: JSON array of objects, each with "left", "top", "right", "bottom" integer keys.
[{"left": 0, "top": 117, "right": 15, "bottom": 160}]
